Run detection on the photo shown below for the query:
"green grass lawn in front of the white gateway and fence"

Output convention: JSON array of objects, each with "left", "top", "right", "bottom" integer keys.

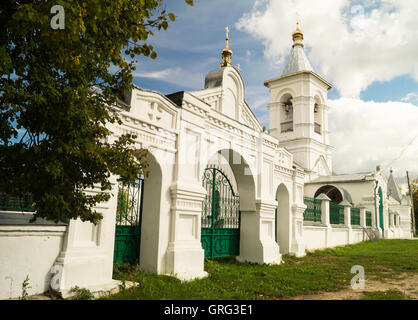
[{"left": 102, "top": 240, "right": 418, "bottom": 300}]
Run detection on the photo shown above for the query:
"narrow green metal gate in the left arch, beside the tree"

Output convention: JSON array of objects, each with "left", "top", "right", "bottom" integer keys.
[{"left": 113, "top": 176, "right": 144, "bottom": 265}]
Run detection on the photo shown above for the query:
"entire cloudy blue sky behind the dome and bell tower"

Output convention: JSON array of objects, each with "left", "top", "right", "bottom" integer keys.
[{"left": 134, "top": 0, "right": 418, "bottom": 184}]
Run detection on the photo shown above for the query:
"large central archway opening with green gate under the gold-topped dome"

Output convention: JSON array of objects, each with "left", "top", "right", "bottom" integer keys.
[{"left": 201, "top": 149, "right": 255, "bottom": 258}]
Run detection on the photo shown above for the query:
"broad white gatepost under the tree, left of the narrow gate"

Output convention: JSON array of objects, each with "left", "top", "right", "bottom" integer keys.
[{"left": 51, "top": 175, "right": 120, "bottom": 298}]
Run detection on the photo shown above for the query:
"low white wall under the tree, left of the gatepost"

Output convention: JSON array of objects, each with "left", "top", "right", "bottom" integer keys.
[{"left": 0, "top": 212, "right": 67, "bottom": 299}]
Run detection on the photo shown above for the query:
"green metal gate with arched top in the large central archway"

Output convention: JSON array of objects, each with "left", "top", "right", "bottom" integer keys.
[{"left": 201, "top": 168, "right": 241, "bottom": 258}]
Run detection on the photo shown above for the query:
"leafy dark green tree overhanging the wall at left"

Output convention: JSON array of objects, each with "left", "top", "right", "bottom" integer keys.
[{"left": 0, "top": 0, "right": 193, "bottom": 223}]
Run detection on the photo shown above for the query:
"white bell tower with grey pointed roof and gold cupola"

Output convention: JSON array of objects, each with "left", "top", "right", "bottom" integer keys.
[{"left": 264, "top": 22, "right": 332, "bottom": 178}]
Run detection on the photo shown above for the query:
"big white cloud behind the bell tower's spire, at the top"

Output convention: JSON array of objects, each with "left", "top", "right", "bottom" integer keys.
[{"left": 236, "top": 0, "right": 418, "bottom": 97}]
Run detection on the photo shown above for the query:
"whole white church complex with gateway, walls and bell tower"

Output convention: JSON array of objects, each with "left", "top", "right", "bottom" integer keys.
[{"left": 0, "top": 26, "right": 412, "bottom": 299}]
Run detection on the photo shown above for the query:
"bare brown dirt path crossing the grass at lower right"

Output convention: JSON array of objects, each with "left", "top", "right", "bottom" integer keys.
[{"left": 290, "top": 273, "right": 418, "bottom": 300}]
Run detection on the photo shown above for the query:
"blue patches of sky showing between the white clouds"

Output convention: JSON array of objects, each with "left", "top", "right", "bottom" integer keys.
[{"left": 134, "top": 0, "right": 418, "bottom": 105}]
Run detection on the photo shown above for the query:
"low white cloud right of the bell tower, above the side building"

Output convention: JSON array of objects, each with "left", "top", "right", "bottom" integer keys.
[{"left": 328, "top": 98, "right": 418, "bottom": 177}]
